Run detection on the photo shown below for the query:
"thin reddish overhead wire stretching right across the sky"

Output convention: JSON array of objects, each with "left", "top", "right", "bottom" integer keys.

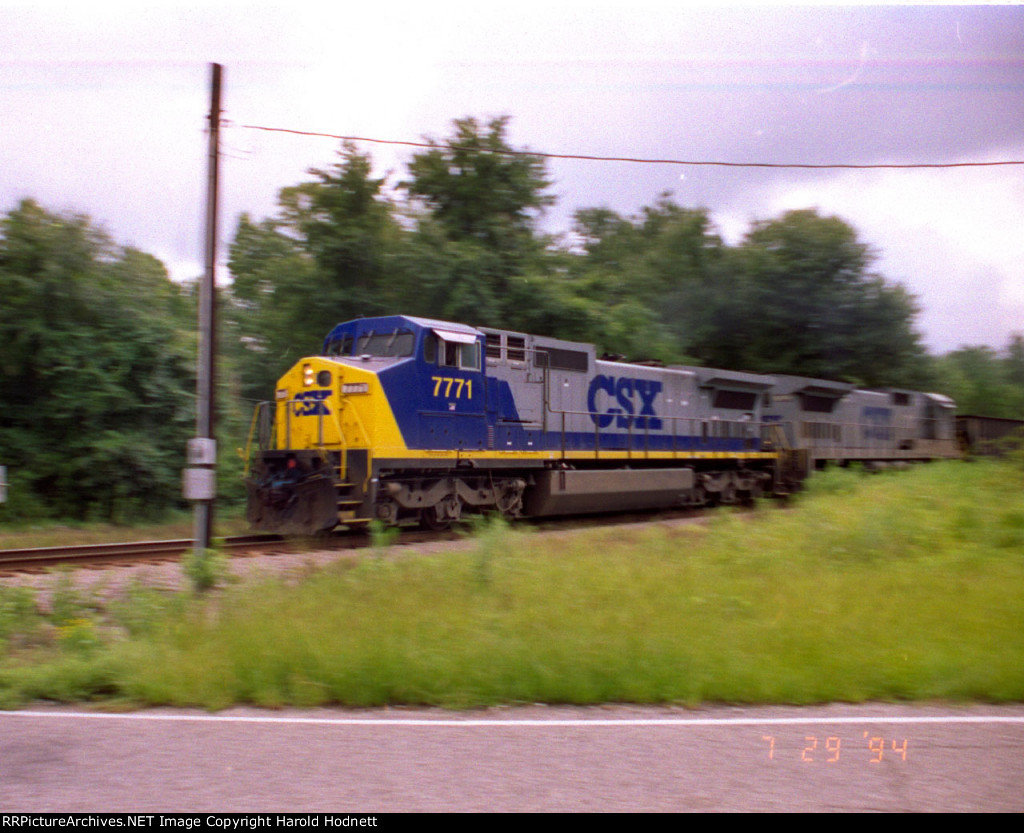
[{"left": 241, "top": 124, "right": 1024, "bottom": 170}]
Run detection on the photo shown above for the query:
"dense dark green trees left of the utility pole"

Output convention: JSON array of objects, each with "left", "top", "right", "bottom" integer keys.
[{"left": 0, "top": 200, "right": 195, "bottom": 519}]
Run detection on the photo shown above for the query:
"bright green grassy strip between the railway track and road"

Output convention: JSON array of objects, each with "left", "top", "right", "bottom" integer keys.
[{"left": 0, "top": 461, "right": 1024, "bottom": 708}]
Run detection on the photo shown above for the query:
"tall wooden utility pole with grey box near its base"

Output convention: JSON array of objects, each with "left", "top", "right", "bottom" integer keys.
[{"left": 184, "top": 64, "right": 222, "bottom": 558}]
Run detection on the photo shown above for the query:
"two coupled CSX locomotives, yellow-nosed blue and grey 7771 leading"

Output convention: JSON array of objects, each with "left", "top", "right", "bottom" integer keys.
[{"left": 246, "top": 316, "right": 958, "bottom": 535}]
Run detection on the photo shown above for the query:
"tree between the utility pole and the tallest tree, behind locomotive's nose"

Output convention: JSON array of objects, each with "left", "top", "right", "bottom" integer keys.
[{"left": 228, "top": 143, "right": 401, "bottom": 399}]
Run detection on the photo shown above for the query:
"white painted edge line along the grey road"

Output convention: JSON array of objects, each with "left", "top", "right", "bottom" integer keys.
[{"left": 6, "top": 711, "right": 1024, "bottom": 728}]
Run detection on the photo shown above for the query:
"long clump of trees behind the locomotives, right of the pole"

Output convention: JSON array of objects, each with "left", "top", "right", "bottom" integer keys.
[{"left": 230, "top": 117, "right": 928, "bottom": 395}]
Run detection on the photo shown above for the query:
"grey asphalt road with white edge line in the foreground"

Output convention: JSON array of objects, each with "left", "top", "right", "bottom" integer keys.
[{"left": 0, "top": 704, "right": 1024, "bottom": 821}]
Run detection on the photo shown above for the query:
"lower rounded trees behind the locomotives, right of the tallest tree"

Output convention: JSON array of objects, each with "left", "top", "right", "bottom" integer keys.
[{"left": 570, "top": 201, "right": 927, "bottom": 377}]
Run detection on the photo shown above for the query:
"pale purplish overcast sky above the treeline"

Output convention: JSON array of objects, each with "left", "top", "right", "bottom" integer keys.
[{"left": 0, "top": 0, "right": 1024, "bottom": 352}]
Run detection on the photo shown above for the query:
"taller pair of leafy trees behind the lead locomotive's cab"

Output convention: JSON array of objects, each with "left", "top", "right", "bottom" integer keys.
[{"left": 228, "top": 112, "right": 592, "bottom": 370}]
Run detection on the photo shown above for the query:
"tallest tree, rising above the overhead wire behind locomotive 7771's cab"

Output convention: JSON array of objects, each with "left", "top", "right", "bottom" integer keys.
[{"left": 392, "top": 117, "right": 559, "bottom": 334}]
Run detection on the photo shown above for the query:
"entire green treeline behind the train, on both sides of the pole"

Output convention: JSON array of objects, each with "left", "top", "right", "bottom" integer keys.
[{"left": 6, "top": 117, "right": 1024, "bottom": 523}]
